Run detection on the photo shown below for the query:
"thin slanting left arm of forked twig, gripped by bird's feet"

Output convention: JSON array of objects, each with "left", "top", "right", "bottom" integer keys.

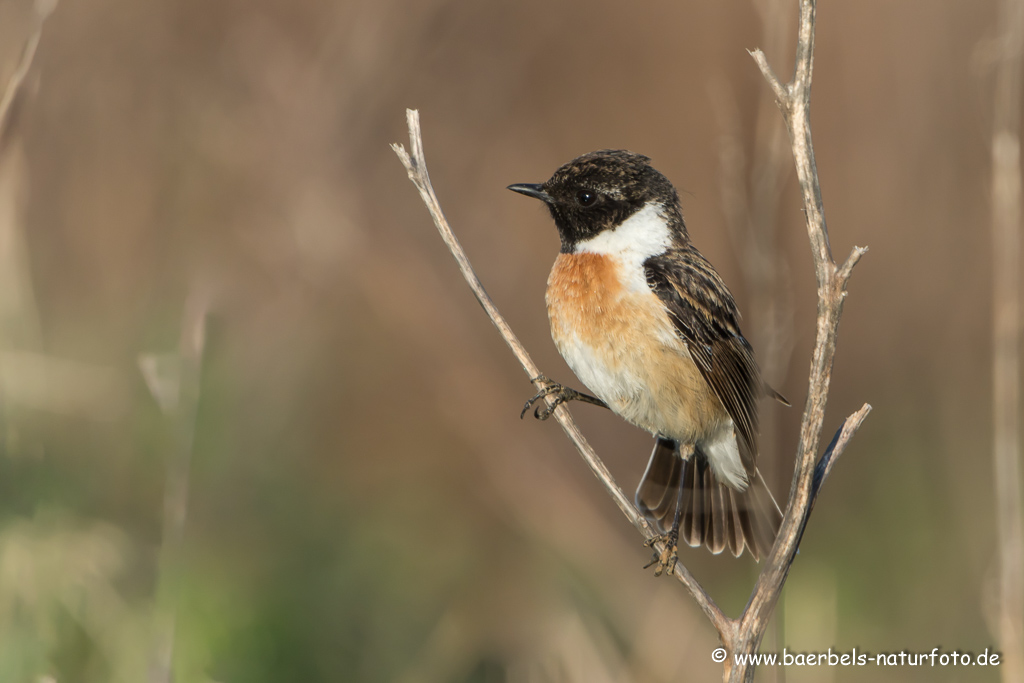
[{"left": 391, "top": 110, "right": 733, "bottom": 641}]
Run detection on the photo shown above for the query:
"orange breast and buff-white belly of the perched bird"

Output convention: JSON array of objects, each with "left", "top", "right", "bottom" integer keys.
[{"left": 547, "top": 252, "right": 728, "bottom": 441}]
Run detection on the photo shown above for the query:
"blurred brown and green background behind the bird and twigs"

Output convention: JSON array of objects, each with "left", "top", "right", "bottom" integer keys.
[{"left": 0, "top": 0, "right": 1019, "bottom": 683}]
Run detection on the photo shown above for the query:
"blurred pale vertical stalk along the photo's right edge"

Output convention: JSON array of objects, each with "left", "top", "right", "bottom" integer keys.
[{"left": 991, "top": 0, "right": 1024, "bottom": 681}]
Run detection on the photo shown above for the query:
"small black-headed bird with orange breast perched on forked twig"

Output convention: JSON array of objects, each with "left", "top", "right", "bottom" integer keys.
[{"left": 508, "top": 150, "right": 790, "bottom": 574}]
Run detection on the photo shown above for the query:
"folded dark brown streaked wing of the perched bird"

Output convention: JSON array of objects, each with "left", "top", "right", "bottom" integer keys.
[{"left": 644, "top": 246, "right": 763, "bottom": 474}]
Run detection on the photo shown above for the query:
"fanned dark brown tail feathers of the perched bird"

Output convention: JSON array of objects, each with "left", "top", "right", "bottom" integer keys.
[{"left": 636, "top": 437, "right": 782, "bottom": 560}]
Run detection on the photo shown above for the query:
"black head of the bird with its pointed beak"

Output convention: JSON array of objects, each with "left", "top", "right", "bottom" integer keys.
[{"left": 509, "top": 150, "right": 686, "bottom": 252}]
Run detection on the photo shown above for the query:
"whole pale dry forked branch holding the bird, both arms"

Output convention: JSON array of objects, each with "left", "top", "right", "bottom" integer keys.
[{"left": 391, "top": 0, "right": 871, "bottom": 681}]
